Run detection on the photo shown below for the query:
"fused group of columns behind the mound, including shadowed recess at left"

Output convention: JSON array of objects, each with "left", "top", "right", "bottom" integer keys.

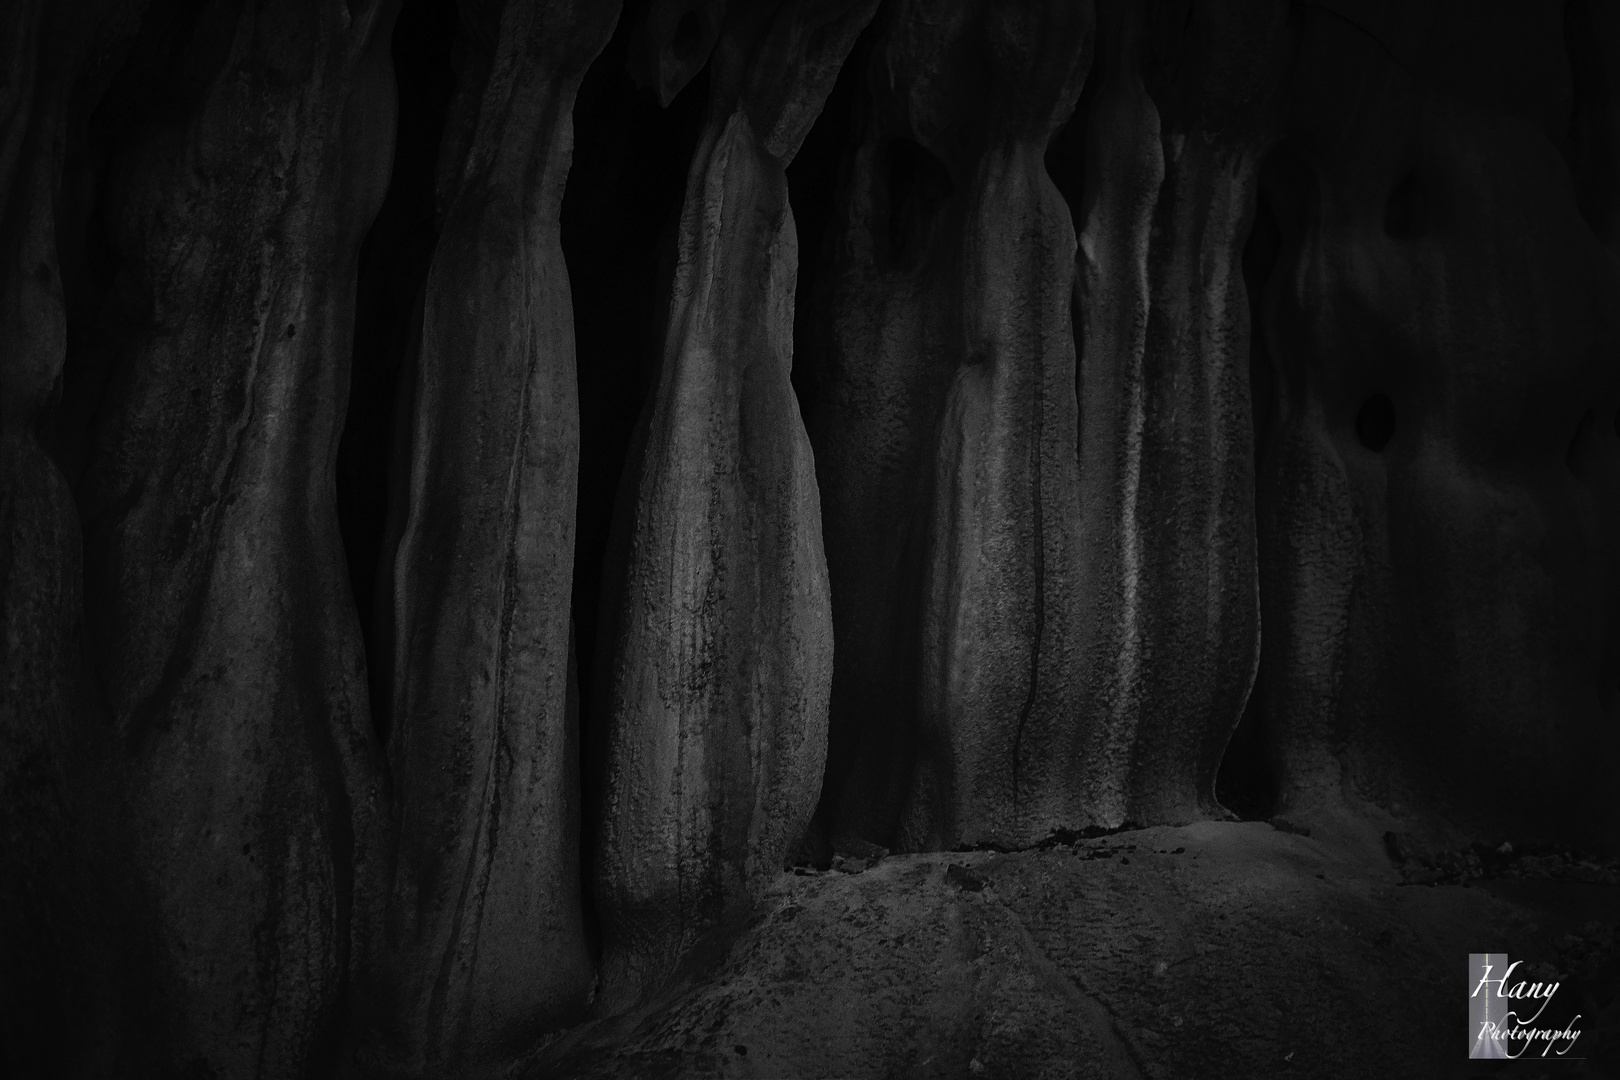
[{"left": 812, "top": 3, "right": 1288, "bottom": 850}]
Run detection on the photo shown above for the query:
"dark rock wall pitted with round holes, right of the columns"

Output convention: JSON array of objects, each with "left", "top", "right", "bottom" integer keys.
[{"left": 1262, "top": 6, "right": 1620, "bottom": 850}]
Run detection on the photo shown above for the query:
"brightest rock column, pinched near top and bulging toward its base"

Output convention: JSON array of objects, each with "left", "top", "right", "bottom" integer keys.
[{"left": 595, "top": 0, "right": 875, "bottom": 1009}]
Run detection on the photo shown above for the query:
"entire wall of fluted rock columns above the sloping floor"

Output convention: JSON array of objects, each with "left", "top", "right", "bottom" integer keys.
[{"left": 0, "top": 0, "right": 1620, "bottom": 1075}]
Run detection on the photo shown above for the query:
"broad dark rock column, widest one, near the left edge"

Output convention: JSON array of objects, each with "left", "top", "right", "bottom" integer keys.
[{"left": 68, "top": 0, "right": 394, "bottom": 1077}]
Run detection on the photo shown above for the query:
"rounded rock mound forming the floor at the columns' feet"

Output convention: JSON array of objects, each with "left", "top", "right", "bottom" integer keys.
[{"left": 537, "top": 823, "right": 1620, "bottom": 1078}]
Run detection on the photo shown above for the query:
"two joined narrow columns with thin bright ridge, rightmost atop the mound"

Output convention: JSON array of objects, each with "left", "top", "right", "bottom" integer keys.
[{"left": 1077, "top": 0, "right": 1286, "bottom": 826}]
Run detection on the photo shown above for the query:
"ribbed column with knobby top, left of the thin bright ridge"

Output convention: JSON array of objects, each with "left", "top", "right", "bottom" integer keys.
[{"left": 894, "top": 0, "right": 1094, "bottom": 850}]
